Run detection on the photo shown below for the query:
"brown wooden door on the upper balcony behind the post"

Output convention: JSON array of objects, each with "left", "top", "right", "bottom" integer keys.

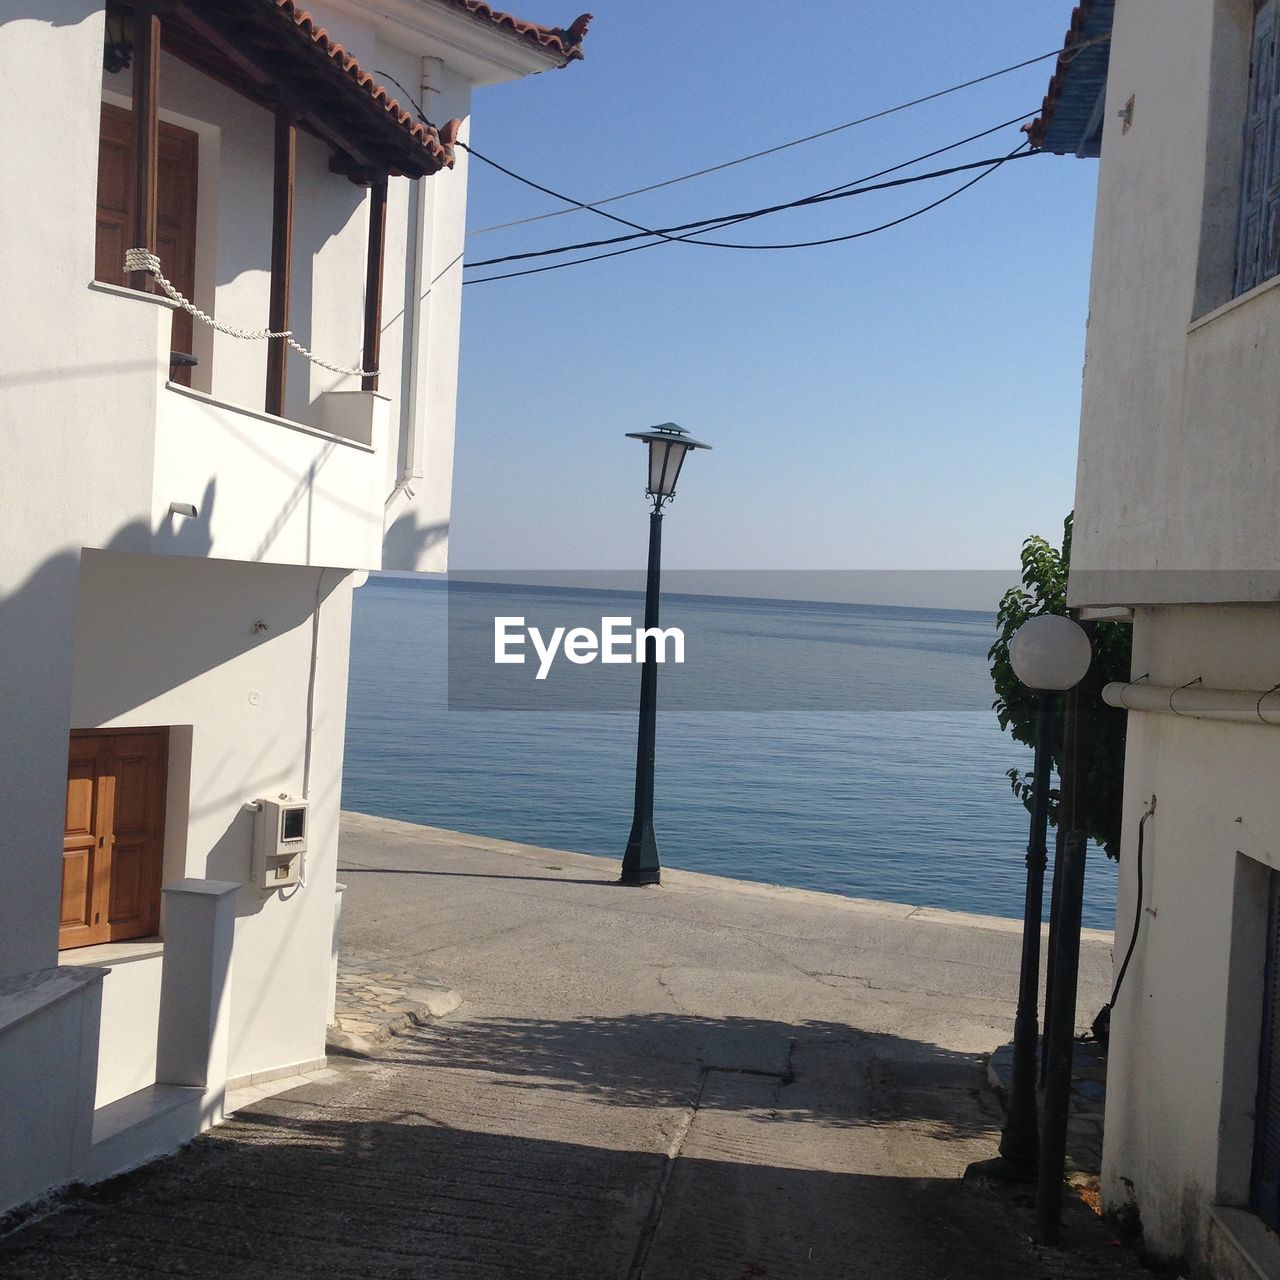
[{"left": 93, "top": 102, "right": 200, "bottom": 387}]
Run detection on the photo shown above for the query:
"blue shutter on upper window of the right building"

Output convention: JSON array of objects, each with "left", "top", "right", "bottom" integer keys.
[{"left": 1235, "top": 0, "right": 1280, "bottom": 294}]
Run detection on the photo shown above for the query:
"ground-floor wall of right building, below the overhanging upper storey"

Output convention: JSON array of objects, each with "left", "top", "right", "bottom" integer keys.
[{"left": 1103, "top": 605, "right": 1280, "bottom": 1256}]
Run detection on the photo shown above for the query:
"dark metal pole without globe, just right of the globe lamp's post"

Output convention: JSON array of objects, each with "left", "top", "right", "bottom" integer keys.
[{"left": 1036, "top": 831, "right": 1085, "bottom": 1244}]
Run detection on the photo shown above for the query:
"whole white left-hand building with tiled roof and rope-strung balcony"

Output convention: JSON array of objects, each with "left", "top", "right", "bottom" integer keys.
[{"left": 0, "top": 0, "right": 586, "bottom": 1212}]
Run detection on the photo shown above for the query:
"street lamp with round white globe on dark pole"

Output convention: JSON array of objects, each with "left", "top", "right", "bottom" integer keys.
[{"left": 982, "top": 613, "right": 1093, "bottom": 1179}]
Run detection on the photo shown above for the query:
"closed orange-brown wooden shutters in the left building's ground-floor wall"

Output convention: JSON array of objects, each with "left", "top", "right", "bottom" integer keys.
[{"left": 58, "top": 728, "right": 169, "bottom": 950}]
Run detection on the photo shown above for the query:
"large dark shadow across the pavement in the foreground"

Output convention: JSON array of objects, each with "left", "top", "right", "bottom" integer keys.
[{"left": 0, "top": 1089, "right": 1146, "bottom": 1280}]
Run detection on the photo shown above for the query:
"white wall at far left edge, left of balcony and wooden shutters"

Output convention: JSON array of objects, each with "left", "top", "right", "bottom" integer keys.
[{"left": 0, "top": 0, "right": 169, "bottom": 975}]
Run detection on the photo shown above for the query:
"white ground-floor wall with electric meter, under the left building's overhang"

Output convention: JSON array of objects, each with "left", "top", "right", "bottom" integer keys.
[{"left": 70, "top": 552, "right": 351, "bottom": 1076}]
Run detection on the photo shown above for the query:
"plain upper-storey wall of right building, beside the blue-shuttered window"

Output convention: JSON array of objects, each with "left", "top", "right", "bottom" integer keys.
[{"left": 1071, "top": 0, "right": 1259, "bottom": 604}]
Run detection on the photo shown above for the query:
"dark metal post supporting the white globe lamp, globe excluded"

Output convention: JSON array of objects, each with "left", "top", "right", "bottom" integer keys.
[{"left": 1000, "top": 692, "right": 1053, "bottom": 1179}]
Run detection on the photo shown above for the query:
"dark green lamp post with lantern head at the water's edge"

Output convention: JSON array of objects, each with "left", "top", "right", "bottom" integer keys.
[{"left": 622, "top": 422, "right": 710, "bottom": 884}]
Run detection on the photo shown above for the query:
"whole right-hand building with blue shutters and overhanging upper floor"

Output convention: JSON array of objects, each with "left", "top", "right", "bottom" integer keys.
[{"left": 1032, "top": 0, "right": 1280, "bottom": 1276}]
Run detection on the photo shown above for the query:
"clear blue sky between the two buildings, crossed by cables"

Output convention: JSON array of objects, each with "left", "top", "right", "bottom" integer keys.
[{"left": 451, "top": 0, "right": 1097, "bottom": 581}]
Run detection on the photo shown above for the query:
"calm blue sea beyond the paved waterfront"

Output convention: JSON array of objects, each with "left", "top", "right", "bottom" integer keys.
[{"left": 343, "top": 579, "right": 1115, "bottom": 928}]
